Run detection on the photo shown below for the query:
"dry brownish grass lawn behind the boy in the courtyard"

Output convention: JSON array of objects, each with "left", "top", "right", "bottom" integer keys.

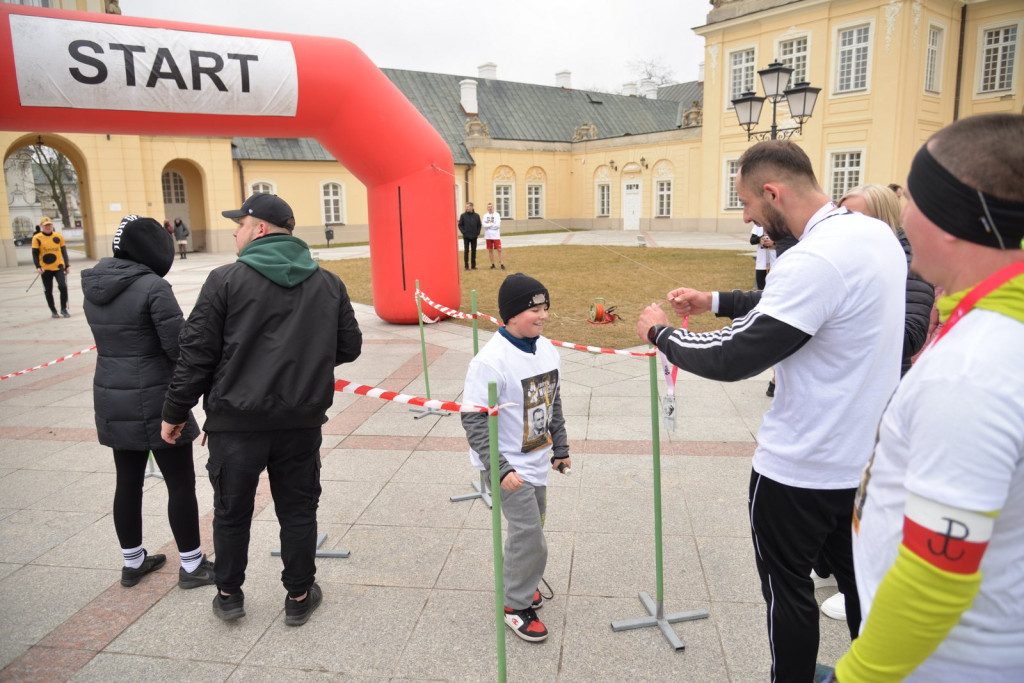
[{"left": 321, "top": 245, "right": 754, "bottom": 348}]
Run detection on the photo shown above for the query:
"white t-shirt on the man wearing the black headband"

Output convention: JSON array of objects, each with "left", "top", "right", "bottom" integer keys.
[{"left": 853, "top": 309, "right": 1024, "bottom": 681}]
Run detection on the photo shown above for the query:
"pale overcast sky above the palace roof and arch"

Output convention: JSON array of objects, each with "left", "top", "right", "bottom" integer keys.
[{"left": 121, "top": 0, "right": 711, "bottom": 92}]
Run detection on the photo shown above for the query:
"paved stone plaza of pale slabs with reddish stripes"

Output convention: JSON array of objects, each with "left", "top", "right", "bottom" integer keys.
[{"left": 0, "top": 232, "right": 849, "bottom": 683}]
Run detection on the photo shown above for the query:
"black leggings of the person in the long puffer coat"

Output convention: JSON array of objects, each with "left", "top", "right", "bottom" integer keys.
[{"left": 114, "top": 442, "right": 200, "bottom": 553}]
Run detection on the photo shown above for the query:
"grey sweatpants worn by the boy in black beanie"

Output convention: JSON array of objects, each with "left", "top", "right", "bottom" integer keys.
[{"left": 493, "top": 481, "right": 548, "bottom": 609}]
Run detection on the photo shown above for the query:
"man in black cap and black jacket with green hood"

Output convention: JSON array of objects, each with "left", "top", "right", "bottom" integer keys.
[{"left": 163, "top": 194, "right": 362, "bottom": 626}]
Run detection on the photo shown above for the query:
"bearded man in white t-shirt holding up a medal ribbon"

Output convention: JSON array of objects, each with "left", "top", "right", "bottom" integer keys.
[{"left": 637, "top": 140, "right": 906, "bottom": 683}]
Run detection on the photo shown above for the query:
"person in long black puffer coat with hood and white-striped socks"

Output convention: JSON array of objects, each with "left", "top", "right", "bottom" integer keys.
[{"left": 82, "top": 215, "right": 213, "bottom": 589}]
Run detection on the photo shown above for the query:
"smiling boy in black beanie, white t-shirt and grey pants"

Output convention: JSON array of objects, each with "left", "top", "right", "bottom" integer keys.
[{"left": 462, "top": 272, "right": 572, "bottom": 642}]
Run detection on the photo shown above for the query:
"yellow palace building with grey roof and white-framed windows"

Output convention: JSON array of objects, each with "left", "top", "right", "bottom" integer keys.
[{"left": 0, "top": 0, "right": 1024, "bottom": 266}]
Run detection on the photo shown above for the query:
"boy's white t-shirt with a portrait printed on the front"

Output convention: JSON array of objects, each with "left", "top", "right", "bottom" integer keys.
[{"left": 462, "top": 333, "right": 562, "bottom": 486}]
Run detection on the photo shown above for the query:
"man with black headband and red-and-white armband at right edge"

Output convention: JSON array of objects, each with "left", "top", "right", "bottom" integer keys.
[{"left": 836, "top": 114, "right": 1024, "bottom": 683}]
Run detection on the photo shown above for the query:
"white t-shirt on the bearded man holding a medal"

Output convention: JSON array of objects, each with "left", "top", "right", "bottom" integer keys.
[{"left": 754, "top": 203, "right": 906, "bottom": 489}]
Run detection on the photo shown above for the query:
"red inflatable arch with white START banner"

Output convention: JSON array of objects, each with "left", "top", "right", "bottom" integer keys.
[{"left": 0, "top": 3, "right": 460, "bottom": 323}]
